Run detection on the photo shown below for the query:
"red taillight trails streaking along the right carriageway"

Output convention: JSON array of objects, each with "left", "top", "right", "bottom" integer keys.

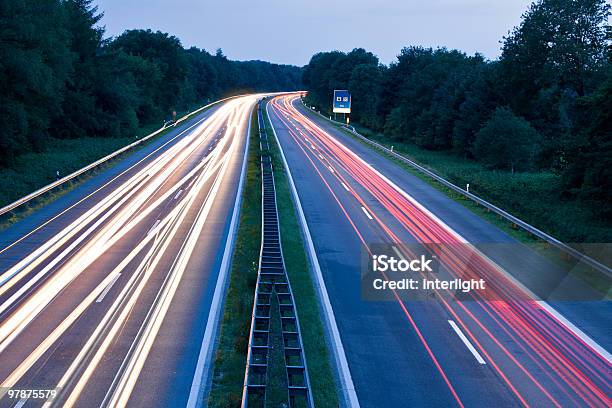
[{"left": 269, "top": 96, "right": 612, "bottom": 406}]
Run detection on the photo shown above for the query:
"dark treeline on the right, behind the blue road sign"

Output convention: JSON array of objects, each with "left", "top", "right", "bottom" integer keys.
[{"left": 303, "top": 0, "right": 612, "bottom": 220}]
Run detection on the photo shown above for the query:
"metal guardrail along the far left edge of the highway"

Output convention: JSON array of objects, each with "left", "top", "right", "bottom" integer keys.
[{"left": 0, "top": 95, "right": 240, "bottom": 216}]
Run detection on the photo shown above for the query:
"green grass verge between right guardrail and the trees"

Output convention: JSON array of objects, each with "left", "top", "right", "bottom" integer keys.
[{"left": 330, "top": 116, "right": 612, "bottom": 243}]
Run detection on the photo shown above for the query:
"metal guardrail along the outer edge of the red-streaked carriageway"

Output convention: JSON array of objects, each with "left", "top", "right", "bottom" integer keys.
[{"left": 304, "top": 100, "right": 612, "bottom": 278}]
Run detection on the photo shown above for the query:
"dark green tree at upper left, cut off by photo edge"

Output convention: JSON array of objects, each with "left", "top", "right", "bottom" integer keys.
[{"left": 0, "top": 0, "right": 71, "bottom": 164}]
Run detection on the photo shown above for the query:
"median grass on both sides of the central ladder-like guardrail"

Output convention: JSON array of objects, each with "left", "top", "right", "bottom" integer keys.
[{"left": 206, "top": 103, "right": 338, "bottom": 408}]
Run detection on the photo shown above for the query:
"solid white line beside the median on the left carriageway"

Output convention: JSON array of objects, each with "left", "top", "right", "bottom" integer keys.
[{"left": 186, "top": 102, "right": 253, "bottom": 408}]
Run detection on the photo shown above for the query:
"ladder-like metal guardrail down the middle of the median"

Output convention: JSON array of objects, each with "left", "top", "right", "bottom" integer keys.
[{"left": 242, "top": 104, "right": 314, "bottom": 408}]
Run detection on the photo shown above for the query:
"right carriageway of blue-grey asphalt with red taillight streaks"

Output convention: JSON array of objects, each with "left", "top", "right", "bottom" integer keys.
[{"left": 267, "top": 95, "right": 612, "bottom": 407}]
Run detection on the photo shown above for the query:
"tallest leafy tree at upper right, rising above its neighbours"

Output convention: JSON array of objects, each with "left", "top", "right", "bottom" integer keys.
[{"left": 499, "top": 0, "right": 611, "bottom": 168}]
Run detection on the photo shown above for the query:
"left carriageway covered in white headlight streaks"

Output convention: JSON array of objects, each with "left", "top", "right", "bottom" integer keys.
[{"left": 0, "top": 95, "right": 259, "bottom": 407}]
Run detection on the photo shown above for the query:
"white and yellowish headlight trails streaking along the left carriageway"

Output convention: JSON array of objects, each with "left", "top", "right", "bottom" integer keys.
[{"left": 0, "top": 95, "right": 261, "bottom": 406}]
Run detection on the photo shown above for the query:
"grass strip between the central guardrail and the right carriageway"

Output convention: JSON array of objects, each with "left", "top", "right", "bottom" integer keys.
[{"left": 263, "top": 103, "right": 338, "bottom": 407}]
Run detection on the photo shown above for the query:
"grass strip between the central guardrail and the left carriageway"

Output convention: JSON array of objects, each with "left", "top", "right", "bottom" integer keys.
[{"left": 207, "top": 112, "right": 261, "bottom": 407}]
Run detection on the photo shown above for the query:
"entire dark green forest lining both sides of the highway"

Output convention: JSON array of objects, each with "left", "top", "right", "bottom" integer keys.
[{"left": 0, "top": 0, "right": 612, "bottom": 242}]
